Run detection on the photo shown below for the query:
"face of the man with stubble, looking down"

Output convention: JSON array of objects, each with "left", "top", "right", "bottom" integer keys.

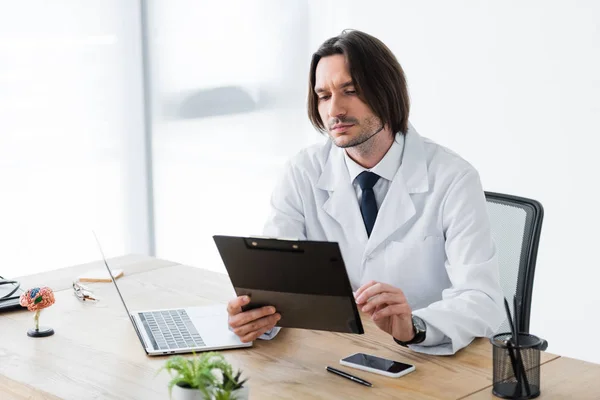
[{"left": 314, "top": 54, "right": 381, "bottom": 148}]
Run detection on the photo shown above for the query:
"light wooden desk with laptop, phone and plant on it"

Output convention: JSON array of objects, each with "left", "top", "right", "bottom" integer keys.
[{"left": 0, "top": 256, "right": 600, "bottom": 399}]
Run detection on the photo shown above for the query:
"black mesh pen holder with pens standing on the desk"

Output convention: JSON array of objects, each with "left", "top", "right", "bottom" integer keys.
[{"left": 490, "top": 296, "right": 548, "bottom": 399}]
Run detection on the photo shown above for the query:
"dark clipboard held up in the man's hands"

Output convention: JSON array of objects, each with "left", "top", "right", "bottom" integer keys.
[{"left": 213, "top": 235, "right": 364, "bottom": 334}]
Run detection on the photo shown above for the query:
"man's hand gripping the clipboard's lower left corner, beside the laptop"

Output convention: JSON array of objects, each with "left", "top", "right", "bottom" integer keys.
[{"left": 227, "top": 296, "right": 281, "bottom": 343}]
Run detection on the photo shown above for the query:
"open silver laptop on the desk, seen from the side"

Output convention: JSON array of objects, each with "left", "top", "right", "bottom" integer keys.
[{"left": 94, "top": 235, "right": 252, "bottom": 356}]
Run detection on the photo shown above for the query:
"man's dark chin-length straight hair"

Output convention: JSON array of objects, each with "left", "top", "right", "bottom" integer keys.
[{"left": 308, "top": 30, "right": 410, "bottom": 134}]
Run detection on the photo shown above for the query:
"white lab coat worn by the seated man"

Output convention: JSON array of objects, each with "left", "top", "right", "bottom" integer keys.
[{"left": 264, "top": 126, "right": 504, "bottom": 354}]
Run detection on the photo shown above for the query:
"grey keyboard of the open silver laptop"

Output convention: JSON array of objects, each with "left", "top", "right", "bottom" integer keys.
[{"left": 139, "top": 309, "right": 206, "bottom": 350}]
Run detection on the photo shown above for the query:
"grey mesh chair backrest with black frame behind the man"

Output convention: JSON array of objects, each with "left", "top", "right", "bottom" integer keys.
[{"left": 485, "top": 192, "right": 544, "bottom": 333}]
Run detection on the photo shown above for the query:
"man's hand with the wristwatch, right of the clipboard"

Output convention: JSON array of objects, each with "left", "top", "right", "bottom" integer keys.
[{"left": 354, "top": 281, "right": 415, "bottom": 342}]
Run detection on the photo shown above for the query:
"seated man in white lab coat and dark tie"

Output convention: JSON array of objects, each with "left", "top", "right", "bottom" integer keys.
[{"left": 228, "top": 31, "right": 503, "bottom": 354}]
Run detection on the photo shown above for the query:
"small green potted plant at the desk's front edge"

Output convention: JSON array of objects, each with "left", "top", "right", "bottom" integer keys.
[{"left": 159, "top": 352, "right": 249, "bottom": 400}]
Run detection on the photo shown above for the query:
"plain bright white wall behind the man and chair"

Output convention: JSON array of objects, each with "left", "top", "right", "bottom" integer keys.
[{"left": 310, "top": 0, "right": 600, "bottom": 362}]
